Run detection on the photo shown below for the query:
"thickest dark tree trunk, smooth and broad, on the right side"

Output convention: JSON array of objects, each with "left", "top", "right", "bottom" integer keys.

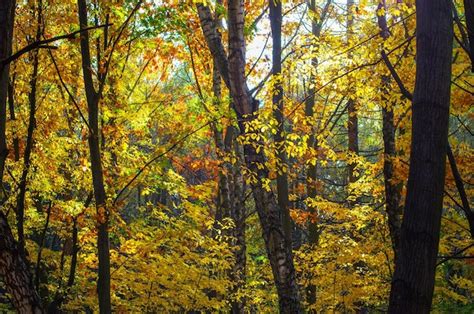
[{"left": 389, "top": 0, "right": 453, "bottom": 313}]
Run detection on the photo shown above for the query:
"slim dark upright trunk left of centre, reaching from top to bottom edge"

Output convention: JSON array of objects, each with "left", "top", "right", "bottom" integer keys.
[{"left": 78, "top": 0, "right": 112, "bottom": 313}]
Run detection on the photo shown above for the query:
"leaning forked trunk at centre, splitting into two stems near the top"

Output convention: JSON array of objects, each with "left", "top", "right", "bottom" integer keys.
[{"left": 197, "top": 0, "right": 300, "bottom": 313}]
